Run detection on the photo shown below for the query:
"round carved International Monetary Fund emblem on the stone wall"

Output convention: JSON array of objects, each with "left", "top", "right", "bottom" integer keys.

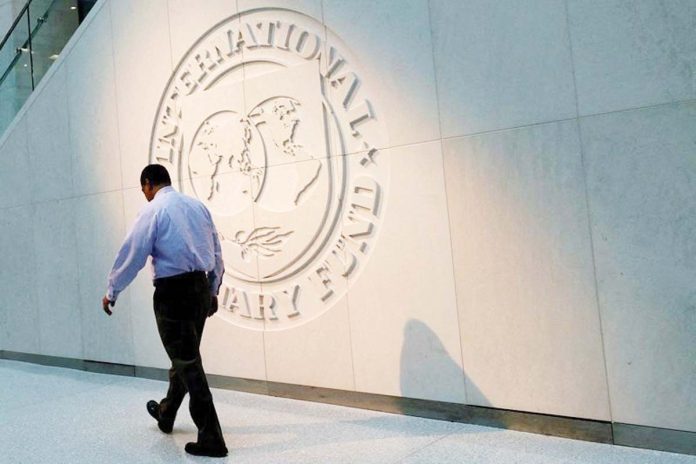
[{"left": 150, "top": 9, "right": 389, "bottom": 330}]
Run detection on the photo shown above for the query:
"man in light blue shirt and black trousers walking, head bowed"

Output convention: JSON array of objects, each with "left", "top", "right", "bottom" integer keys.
[{"left": 102, "top": 164, "right": 227, "bottom": 457}]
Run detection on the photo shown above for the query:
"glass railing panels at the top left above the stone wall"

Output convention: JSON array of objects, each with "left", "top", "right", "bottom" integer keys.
[{"left": 0, "top": 0, "right": 96, "bottom": 137}]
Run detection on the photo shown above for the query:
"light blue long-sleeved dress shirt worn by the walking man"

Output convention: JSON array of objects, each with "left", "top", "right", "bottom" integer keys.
[{"left": 106, "top": 187, "right": 224, "bottom": 301}]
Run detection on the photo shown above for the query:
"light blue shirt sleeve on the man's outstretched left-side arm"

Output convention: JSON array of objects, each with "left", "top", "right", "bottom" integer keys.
[{"left": 106, "top": 208, "right": 157, "bottom": 301}]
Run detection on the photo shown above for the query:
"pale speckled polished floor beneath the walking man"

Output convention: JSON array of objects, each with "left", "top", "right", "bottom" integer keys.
[{"left": 0, "top": 360, "right": 696, "bottom": 464}]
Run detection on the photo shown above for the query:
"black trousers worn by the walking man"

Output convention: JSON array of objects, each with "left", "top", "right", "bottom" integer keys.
[{"left": 153, "top": 272, "right": 225, "bottom": 446}]
